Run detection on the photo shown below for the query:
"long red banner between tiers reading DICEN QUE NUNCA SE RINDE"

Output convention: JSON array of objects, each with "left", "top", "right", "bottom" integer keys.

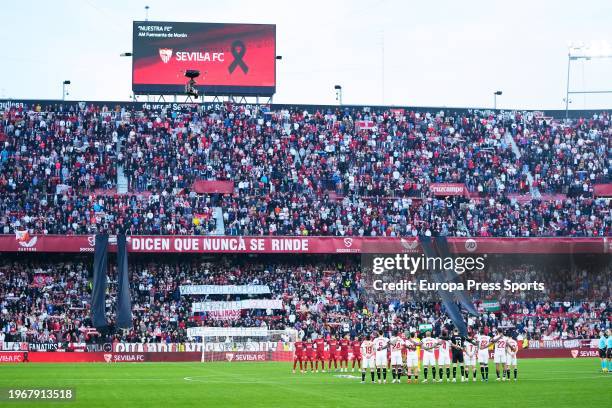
[{"left": 0, "top": 234, "right": 612, "bottom": 254}]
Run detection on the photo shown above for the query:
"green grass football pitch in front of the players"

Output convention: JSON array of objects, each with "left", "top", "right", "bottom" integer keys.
[{"left": 0, "top": 359, "right": 612, "bottom": 408}]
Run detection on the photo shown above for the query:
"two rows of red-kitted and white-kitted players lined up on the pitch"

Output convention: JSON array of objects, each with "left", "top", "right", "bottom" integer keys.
[{"left": 293, "top": 329, "right": 518, "bottom": 383}]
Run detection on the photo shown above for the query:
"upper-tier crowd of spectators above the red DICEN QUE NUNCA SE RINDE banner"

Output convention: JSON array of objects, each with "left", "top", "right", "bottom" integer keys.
[{"left": 0, "top": 104, "right": 612, "bottom": 237}]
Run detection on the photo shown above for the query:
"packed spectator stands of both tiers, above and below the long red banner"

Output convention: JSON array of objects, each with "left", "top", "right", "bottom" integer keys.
[{"left": 0, "top": 101, "right": 612, "bottom": 354}]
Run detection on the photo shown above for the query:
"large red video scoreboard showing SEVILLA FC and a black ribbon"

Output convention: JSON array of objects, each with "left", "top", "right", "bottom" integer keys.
[{"left": 132, "top": 21, "right": 276, "bottom": 96}]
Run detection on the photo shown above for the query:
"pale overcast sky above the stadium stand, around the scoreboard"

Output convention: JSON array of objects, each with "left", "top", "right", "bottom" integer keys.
[{"left": 0, "top": 0, "right": 612, "bottom": 109}]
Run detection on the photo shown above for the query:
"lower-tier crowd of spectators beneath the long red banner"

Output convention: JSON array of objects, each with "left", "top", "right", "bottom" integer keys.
[{"left": 0, "top": 256, "right": 612, "bottom": 343}]
